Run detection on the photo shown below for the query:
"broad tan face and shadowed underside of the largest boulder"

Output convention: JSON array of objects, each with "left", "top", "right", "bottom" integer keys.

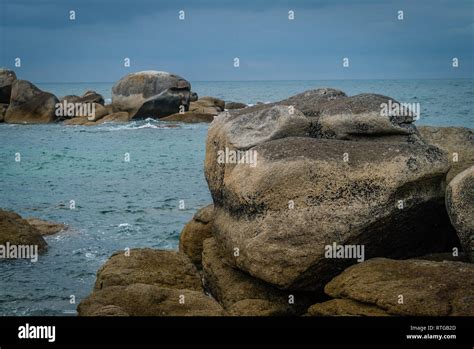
[{"left": 206, "top": 135, "right": 459, "bottom": 290}]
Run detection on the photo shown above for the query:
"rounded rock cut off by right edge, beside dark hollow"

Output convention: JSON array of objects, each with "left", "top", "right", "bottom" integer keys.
[{"left": 446, "top": 166, "right": 474, "bottom": 262}]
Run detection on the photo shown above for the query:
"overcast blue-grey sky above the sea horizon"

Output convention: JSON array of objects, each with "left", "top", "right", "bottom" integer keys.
[{"left": 0, "top": 0, "right": 474, "bottom": 83}]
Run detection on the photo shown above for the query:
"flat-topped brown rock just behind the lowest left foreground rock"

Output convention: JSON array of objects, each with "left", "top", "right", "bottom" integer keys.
[{"left": 95, "top": 248, "right": 202, "bottom": 291}]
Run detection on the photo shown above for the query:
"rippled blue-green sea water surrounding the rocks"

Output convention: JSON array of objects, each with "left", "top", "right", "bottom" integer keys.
[{"left": 0, "top": 79, "right": 474, "bottom": 315}]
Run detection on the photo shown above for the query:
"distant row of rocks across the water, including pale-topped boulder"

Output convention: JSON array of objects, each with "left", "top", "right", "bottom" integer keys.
[{"left": 0, "top": 68, "right": 247, "bottom": 126}]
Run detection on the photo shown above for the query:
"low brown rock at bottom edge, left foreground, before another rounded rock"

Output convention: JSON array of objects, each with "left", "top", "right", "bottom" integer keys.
[{"left": 77, "top": 283, "right": 225, "bottom": 316}]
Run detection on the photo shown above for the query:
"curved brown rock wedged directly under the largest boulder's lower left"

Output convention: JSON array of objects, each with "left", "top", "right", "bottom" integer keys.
[{"left": 202, "top": 238, "right": 311, "bottom": 316}]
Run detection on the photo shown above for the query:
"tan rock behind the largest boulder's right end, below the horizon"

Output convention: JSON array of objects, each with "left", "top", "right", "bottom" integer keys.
[{"left": 418, "top": 126, "right": 474, "bottom": 183}]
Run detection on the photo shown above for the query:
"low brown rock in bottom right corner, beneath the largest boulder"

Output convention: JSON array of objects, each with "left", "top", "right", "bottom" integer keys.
[{"left": 309, "top": 258, "right": 474, "bottom": 316}]
